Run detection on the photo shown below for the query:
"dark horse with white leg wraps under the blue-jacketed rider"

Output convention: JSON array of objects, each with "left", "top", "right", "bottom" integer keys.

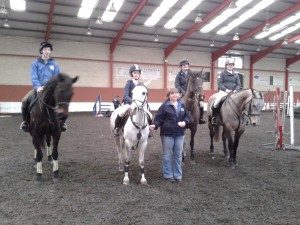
[{"left": 29, "top": 74, "right": 78, "bottom": 183}]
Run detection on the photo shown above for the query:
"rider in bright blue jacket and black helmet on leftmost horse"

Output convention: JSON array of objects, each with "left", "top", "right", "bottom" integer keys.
[{"left": 20, "top": 41, "right": 67, "bottom": 132}]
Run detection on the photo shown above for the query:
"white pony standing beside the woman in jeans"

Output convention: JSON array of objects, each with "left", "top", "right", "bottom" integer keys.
[{"left": 110, "top": 84, "right": 152, "bottom": 185}]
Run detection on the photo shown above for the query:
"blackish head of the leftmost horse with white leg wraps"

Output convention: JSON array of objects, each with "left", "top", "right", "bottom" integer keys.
[{"left": 54, "top": 74, "right": 78, "bottom": 119}]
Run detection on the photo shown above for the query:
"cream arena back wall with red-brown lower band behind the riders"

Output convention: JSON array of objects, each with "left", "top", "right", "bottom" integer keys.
[{"left": 0, "top": 37, "right": 300, "bottom": 113}]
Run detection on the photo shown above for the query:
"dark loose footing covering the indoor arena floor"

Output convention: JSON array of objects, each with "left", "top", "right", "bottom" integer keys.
[{"left": 0, "top": 112, "right": 300, "bottom": 225}]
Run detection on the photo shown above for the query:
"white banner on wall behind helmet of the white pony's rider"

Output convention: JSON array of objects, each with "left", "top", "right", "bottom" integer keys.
[{"left": 115, "top": 66, "right": 160, "bottom": 80}]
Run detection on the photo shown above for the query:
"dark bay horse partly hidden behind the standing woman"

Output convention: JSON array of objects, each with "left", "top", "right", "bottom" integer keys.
[{"left": 182, "top": 69, "right": 203, "bottom": 163}]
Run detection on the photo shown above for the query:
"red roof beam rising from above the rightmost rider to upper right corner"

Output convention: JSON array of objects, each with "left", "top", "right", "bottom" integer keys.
[{"left": 212, "top": 2, "right": 300, "bottom": 61}]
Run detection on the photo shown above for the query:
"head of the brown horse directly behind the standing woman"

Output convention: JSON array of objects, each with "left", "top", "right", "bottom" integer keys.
[{"left": 186, "top": 69, "right": 203, "bottom": 98}]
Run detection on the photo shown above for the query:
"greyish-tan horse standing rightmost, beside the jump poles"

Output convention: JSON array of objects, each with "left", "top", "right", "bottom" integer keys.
[{"left": 207, "top": 89, "right": 264, "bottom": 169}]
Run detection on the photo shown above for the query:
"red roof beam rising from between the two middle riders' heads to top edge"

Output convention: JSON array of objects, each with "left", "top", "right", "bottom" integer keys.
[{"left": 165, "top": 0, "right": 231, "bottom": 58}]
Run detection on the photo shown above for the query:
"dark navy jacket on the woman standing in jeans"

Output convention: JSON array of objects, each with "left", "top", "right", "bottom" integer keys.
[{"left": 152, "top": 101, "right": 190, "bottom": 137}]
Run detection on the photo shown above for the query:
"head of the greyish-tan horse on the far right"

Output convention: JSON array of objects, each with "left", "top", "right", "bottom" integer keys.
[{"left": 246, "top": 90, "right": 264, "bottom": 126}]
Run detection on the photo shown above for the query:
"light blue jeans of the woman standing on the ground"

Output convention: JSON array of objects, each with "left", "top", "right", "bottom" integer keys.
[{"left": 161, "top": 136, "right": 184, "bottom": 180}]
